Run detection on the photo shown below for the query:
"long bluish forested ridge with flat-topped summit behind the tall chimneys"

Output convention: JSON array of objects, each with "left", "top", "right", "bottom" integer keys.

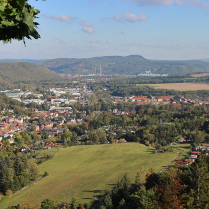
[{"left": 36, "top": 55, "right": 209, "bottom": 75}]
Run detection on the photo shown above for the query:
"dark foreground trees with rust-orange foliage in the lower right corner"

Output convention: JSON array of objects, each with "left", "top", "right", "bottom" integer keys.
[{"left": 90, "top": 156, "right": 209, "bottom": 209}]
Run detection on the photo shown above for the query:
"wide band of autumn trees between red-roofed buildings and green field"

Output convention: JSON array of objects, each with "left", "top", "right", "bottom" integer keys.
[{"left": 73, "top": 103, "right": 209, "bottom": 147}]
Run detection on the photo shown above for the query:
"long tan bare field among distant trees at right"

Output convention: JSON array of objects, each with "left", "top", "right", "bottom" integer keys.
[{"left": 137, "top": 83, "right": 209, "bottom": 91}]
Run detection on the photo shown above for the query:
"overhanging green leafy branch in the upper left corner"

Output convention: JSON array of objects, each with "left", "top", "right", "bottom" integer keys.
[{"left": 0, "top": 0, "right": 40, "bottom": 43}]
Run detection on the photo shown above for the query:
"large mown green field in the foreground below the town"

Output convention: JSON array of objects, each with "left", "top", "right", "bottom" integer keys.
[{"left": 0, "top": 143, "right": 178, "bottom": 208}]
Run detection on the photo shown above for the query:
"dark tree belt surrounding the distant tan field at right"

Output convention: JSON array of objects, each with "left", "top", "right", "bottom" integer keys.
[{"left": 89, "top": 76, "right": 209, "bottom": 98}]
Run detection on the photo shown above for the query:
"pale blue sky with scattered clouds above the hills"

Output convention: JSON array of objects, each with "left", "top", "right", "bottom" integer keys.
[{"left": 0, "top": 0, "right": 209, "bottom": 60}]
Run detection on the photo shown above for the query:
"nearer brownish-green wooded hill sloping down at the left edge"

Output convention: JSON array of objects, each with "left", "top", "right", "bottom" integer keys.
[{"left": 0, "top": 62, "right": 62, "bottom": 83}]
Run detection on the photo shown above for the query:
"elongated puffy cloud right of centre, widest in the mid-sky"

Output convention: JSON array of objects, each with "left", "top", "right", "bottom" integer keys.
[{"left": 113, "top": 12, "right": 148, "bottom": 23}]
